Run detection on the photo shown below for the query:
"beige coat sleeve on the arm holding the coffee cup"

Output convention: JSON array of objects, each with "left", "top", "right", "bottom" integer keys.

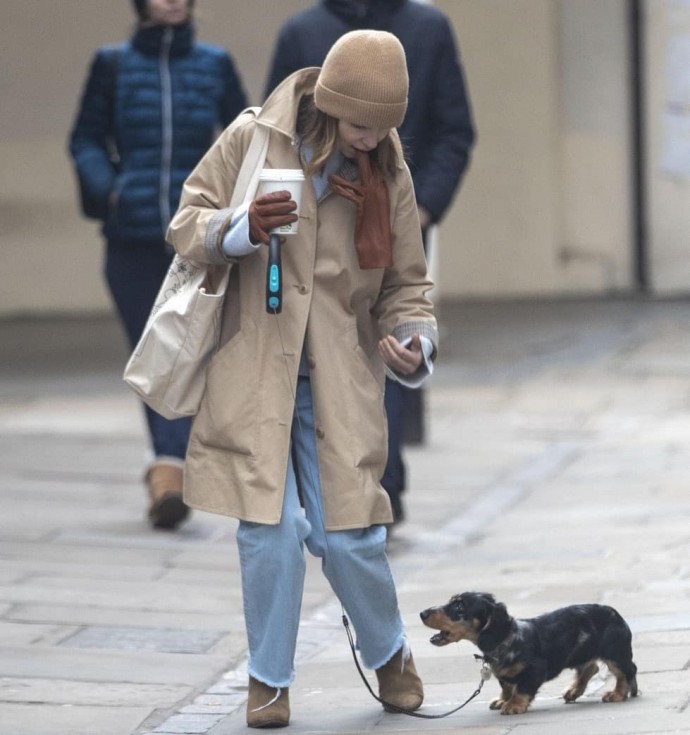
[{"left": 166, "top": 114, "right": 255, "bottom": 265}]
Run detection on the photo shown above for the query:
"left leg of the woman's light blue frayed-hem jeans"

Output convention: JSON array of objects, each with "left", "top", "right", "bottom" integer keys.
[{"left": 237, "top": 448, "right": 309, "bottom": 688}]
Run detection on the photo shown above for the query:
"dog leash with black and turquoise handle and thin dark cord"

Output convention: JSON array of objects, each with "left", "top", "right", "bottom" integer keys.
[{"left": 266, "top": 260, "right": 491, "bottom": 720}]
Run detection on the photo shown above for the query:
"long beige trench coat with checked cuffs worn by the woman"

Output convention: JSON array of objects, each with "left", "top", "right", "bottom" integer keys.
[{"left": 168, "top": 69, "right": 437, "bottom": 530}]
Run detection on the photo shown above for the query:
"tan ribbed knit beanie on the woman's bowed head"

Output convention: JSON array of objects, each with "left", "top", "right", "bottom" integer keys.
[{"left": 314, "top": 30, "right": 408, "bottom": 128}]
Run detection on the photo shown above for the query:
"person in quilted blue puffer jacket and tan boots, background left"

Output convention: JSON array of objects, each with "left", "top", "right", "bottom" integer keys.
[{"left": 69, "top": 0, "right": 247, "bottom": 529}]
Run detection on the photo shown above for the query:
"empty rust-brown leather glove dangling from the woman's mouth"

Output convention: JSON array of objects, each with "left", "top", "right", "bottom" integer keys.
[{"left": 328, "top": 151, "right": 393, "bottom": 269}]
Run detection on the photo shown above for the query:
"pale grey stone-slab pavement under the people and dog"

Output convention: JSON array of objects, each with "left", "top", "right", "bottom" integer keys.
[{"left": 0, "top": 298, "right": 690, "bottom": 735}]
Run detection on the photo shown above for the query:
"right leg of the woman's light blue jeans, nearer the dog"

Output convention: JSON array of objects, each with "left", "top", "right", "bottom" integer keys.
[{"left": 292, "top": 378, "right": 405, "bottom": 669}]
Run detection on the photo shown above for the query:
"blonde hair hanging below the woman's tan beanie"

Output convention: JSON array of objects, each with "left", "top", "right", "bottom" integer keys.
[{"left": 297, "top": 95, "right": 398, "bottom": 177}]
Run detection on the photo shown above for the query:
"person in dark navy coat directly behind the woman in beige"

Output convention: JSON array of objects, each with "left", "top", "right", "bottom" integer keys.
[{"left": 265, "top": 0, "right": 475, "bottom": 522}]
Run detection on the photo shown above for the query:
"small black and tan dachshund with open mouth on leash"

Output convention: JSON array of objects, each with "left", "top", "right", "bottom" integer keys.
[{"left": 420, "top": 592, "right": 637, "bottom": 715}]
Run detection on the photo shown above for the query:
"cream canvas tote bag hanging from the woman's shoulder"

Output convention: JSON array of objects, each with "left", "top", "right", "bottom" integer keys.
[{"left": 123, "top": 108, "right": 269, "bottom": 419}]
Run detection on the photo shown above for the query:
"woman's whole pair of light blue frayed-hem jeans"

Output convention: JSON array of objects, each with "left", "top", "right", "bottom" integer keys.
[{"left": 237, "top": 378, "right": 404, "bottom": 688}]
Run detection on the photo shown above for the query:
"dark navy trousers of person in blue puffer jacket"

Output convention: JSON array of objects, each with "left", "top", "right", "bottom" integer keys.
[{"left": 105, "top": 242, "right": 192, "bottom": 459}]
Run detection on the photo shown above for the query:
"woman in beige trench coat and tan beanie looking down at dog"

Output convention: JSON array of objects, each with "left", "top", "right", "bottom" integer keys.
[{"left": 168, "top": 31, "right": 437, "bottom": 727}]
